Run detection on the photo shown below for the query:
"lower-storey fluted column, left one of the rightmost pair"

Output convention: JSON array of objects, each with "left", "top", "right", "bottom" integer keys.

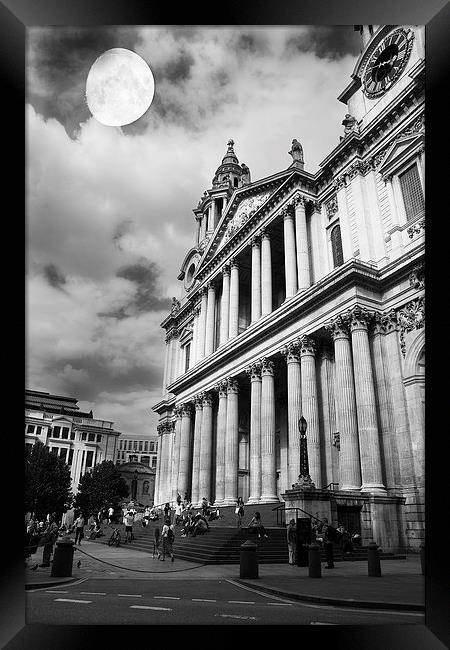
[{"left": 325, "top": 316, "right": 361, "bottom": 490}]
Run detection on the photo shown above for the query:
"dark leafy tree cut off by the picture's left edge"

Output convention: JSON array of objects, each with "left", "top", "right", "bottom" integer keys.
[{"left": 25, "top": 440, "right": 73, "bottom": 518}]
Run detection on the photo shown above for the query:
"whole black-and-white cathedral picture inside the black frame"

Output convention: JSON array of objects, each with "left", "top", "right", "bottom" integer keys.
[{"left": 14, "top": 11, "right": 443, "bottom": 636}]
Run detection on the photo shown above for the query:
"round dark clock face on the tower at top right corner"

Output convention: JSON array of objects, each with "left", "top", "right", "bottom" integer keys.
[{"left": 363, "top": 29, "right": 414, "bottom": 98}]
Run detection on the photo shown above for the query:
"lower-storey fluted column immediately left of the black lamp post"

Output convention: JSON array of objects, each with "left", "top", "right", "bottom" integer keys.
[{"left": 281, "top": 341, "right": 302, "bottom": 489}]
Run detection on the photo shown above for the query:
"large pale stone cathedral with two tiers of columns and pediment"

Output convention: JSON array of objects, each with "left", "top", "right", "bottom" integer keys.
[{"left": 153, "top": 25, "right": 425, "bottom": 550}]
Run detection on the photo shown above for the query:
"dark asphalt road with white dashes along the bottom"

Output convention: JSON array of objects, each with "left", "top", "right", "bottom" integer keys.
[{"left": 26, "top": 577, "right": 424, "bottom": 625}]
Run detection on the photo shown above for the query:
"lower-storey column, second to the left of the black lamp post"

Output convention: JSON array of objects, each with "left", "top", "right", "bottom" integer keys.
[{"left": 261, "top": 358, "right": 278, "bottom": 503}]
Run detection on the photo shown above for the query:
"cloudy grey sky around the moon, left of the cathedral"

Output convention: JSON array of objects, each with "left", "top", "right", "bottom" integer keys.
[{"left": 26, "top": 25, "right": 361, "bottom": 435}]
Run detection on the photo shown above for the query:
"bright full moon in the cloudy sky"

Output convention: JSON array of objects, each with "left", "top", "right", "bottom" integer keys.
[{"left": 86, "top": 47, "right": 155, "bottom": 126}]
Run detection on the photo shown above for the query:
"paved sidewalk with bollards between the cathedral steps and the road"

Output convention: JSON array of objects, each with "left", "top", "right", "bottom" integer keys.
[{"left": 25, "top": 540, "right": 425, "bottom": 612}]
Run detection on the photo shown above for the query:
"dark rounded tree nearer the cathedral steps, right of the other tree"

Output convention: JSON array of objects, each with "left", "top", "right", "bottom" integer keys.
[{"left": 75, "top": 460, "right": 130, "bottom": 513}]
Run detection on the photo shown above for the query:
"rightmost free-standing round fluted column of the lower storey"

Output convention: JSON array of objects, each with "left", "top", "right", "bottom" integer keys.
[{"left": 350, "top": 305, "right": 386, "bottom": 494}]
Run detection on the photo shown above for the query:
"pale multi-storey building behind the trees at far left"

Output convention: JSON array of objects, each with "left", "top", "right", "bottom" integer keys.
[{"left": 25, "top": 390, "right": 120, "bottom": 494}]
